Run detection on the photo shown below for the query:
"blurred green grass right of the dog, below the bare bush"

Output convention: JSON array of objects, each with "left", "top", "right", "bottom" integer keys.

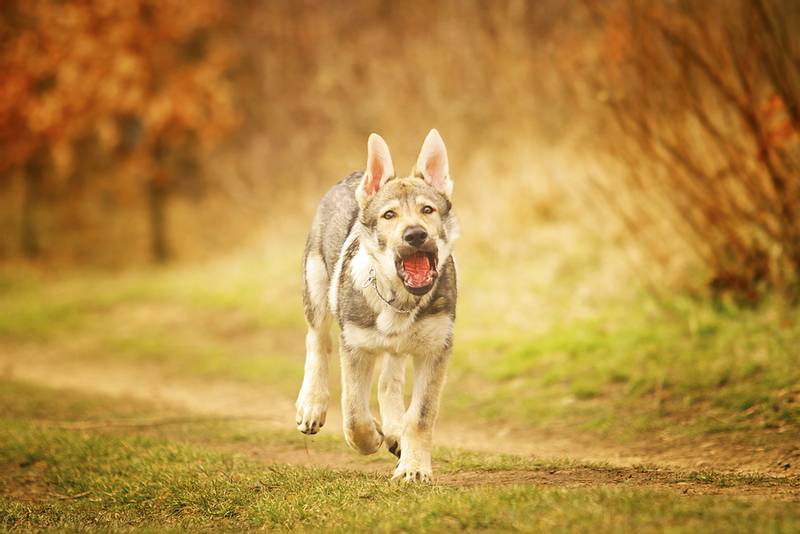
[{"left": 452, "top": 302, "right": 800, "bottom": 440}]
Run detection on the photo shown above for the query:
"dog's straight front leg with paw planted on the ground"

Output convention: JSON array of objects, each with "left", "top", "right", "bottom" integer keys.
[{"left": 392, "top": 349, "right": 450, "bottom": 482}]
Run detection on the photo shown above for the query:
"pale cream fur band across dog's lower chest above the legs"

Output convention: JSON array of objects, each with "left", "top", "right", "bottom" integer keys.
[{"left": 342, "top": 313, "right": 453, "bottom": 354}]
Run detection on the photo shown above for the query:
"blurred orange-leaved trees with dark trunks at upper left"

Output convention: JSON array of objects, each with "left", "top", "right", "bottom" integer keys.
[{"left": 0, "top": 0, "right": 239, "bottom": 260}]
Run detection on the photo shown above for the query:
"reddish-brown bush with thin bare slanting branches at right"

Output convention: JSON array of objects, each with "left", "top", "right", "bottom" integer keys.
[{"left": 585, "top": 0, "right": 800, "bottom": 302}]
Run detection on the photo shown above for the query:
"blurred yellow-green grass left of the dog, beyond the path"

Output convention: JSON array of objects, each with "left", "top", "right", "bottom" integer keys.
[{"left": 0, "top": 262, "right": 304, "bottom": 394}]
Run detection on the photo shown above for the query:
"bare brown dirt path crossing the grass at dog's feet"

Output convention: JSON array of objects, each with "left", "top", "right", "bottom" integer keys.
[{"left": 0, "top": 348, "right": 800, "bottom": 500}]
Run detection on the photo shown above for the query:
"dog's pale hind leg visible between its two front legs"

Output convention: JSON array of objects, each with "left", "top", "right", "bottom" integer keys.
[{"left": 378, "top": 353, "right": 406, "bottom": 458}]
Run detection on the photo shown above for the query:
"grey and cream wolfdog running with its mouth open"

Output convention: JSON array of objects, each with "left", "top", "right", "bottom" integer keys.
[{"left": 296, "top": 129, "right": 458, "bottom": 482}]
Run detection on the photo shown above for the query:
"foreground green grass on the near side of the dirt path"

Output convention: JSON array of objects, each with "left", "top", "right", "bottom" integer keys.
[{"left": 0, "top": 381, "right": 800, "bottom": 532}]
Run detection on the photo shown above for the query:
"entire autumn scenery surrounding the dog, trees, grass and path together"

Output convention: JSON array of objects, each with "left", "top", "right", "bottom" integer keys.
[{"left": 0, "top": 0, "right": 800, "bottom": 532}]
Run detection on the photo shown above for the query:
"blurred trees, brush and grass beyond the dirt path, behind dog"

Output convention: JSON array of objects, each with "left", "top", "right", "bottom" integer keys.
[{"left": 0, "top": 0, "right": 800, "bottom": 467}]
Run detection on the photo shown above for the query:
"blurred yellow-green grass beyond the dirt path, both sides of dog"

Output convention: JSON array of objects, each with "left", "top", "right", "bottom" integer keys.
[{"left": 0, "top": 251, "right": 800, "bottom": 443}]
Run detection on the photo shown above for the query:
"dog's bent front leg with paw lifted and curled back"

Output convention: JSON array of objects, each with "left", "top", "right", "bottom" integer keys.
[{"left": 341, "top": 348, "right": 383, "bottom": 454}]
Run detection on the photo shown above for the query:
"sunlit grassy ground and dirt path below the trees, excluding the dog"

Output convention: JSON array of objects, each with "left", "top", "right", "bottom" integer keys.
[{"left": 0, "top": 202, "right": 800, "bottom": 531}]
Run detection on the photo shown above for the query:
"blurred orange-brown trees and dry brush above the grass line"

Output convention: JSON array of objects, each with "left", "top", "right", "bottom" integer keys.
[{"left": 0, "top": 0, "right": 800, "bottom": 300}]
